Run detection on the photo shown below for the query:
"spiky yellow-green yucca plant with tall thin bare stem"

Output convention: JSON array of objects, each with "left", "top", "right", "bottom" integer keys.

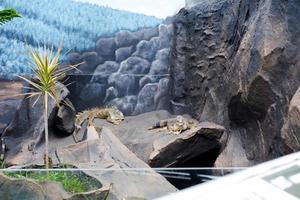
[{"left": 18, "top": 47, "right": 80, "bottom": 169}]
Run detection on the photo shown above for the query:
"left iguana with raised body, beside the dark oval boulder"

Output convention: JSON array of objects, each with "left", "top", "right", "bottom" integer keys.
[{"left": 73, "top": 107, "right": 125, "bottom": 142}]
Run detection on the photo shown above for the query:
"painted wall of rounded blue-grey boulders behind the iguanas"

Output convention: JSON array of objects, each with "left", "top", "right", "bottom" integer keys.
[{"left": 69, "top": 24, "right": 173, "bottom": 115}]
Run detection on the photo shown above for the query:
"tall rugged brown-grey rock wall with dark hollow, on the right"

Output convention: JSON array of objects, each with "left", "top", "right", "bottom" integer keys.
[{"left": 170, "top": 0, "right": 300, "bottom": 167}]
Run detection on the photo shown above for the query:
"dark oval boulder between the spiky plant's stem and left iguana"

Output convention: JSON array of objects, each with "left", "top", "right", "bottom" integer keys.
[{"left": 54, "top": 99, "right": 76, "bottom": 136}]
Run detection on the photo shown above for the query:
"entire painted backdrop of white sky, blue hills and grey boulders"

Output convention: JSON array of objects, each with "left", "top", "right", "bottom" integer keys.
[{"left": 0, "top": 0, "right": 184, "bottom": 115}]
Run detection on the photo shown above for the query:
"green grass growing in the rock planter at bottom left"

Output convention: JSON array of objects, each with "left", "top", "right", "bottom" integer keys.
[{"left": 5, "top": 171, "right": 92, "bottom": 193}]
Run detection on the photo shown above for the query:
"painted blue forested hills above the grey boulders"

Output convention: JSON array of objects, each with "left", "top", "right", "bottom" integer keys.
[{"left": 0, "top": 0, "right": 162, "bottom": 77}]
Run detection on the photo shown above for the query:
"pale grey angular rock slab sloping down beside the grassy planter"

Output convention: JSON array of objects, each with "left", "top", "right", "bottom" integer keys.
[{"left": 56, "top": 126, "right": 176, "bottom": 200}]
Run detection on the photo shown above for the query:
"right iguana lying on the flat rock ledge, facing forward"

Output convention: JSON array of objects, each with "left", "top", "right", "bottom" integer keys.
[{"left": 148, "top": 115, "right": 197, "bottom": 135}]
